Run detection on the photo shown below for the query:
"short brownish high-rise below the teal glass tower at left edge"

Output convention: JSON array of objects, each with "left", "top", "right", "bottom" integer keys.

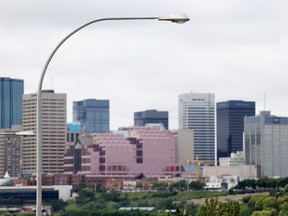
[{"left": 0, "top": 125, "right": 22, "bottom": 177}]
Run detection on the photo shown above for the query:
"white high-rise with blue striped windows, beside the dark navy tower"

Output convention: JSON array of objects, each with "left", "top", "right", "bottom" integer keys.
[{"left": 178, "top": 92, "right": 215, "bottom": 164}]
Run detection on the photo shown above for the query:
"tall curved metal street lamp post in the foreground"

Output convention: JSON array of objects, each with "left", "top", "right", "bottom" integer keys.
[{"left": 36, "top": 14, "right": 189, "bottom": 216}]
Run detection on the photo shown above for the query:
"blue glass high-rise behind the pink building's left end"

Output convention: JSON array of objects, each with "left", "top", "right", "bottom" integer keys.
[{"left": 73, "top": 99, "right": 110, "bottom": 133}]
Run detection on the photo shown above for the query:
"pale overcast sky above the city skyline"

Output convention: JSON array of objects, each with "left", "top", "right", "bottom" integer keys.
[{"left": 0, "top": 0, "right": 288, "bottom": 129}]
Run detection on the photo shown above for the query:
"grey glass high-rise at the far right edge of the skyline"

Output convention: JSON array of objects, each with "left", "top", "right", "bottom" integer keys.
[{"left": 244, "top": 111, "right": 288, "bottom": 178}]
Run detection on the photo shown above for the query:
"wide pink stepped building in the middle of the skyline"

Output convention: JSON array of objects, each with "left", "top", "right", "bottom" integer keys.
[{"left": 64, "top": 126, "right": 180, "bottom": 176}]
